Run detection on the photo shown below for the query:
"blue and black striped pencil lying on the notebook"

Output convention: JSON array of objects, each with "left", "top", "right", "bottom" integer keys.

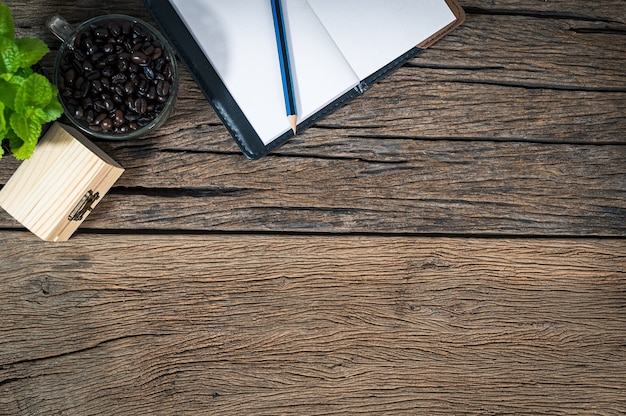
[{"left": 271, "top": 0, "right": 298, "bottom": 134}]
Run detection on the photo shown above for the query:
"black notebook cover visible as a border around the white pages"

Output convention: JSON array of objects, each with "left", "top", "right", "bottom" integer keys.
[{"left": 144, "top": 0, "right": 464, "bottom": 160}]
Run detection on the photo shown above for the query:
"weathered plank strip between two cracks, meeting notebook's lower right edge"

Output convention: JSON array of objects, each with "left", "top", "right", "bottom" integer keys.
[{"left": 298, "top": 80, "right": 626, "bottom": 143}]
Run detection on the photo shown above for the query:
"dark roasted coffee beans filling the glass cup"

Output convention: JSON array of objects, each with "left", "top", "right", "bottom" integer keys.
[{"left": 56, "top": 20, "right": 175, "bottom": 135}]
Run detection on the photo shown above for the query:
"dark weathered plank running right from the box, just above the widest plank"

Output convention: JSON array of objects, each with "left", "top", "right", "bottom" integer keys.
[{"left": 0, "top": 138, "right": 626, "bottom": 236}]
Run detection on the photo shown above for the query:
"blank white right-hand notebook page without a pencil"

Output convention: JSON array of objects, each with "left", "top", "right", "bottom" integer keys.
[{"left": 308, "top": 0, "right": 456, "bottom": 79}]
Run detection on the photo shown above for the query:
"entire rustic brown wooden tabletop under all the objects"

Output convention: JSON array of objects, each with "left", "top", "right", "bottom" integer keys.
[{"left": 0, "top": 0, "right": 626, "bottom": 416}]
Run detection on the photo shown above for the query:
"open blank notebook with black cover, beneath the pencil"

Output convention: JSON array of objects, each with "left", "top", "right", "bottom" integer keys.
[{"left": 144, "top": 0, "right": 463, "bottom": 159}]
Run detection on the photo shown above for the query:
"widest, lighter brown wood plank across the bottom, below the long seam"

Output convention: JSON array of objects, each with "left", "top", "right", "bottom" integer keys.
[{"left": 0, "top": 236, "right": 626, "bottom": 416}]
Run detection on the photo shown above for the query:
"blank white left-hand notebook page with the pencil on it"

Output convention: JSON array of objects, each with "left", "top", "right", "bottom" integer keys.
[{"left": 170, "top": 0, "right": 359, "bottom": 144}]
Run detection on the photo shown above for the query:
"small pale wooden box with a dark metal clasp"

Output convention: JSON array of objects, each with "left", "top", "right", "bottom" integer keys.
[{"left": 0, "top": 123, "right": 124, "bottom": 241}]
